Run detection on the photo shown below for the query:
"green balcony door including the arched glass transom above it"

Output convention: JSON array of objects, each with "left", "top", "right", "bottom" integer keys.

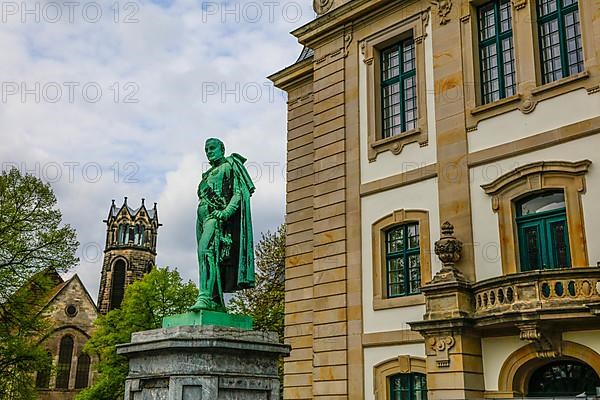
[{"left": 516, "top": 191, "right": 571, "bottom": 271}]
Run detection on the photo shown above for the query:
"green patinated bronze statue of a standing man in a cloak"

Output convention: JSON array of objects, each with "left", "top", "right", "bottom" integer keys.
[{"left": 190, "top": 138, "right": 254, "bottom": 311}]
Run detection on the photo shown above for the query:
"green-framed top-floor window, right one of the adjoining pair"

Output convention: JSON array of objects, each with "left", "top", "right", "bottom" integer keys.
[{"left": 537, "top": 0, "right": 583, "bottom": 83}]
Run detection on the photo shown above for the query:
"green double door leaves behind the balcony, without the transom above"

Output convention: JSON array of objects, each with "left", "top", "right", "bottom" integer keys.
[{"left": 517, "top": 208, "right": 571, "bottom": 271}]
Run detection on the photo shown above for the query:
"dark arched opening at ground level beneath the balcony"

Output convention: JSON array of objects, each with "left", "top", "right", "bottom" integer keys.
[{"left": 527, "top": 360, "right": 600, "bottom": 398}]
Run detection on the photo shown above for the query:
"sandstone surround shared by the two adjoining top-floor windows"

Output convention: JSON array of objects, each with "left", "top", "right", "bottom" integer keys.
[{"left": 460, "top": 0, "right": 600, "bottom": 132}]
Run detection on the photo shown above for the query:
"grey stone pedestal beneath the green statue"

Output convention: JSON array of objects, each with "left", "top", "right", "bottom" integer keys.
[{"left": 117, "top": 325, "right": 290, "bottom": 400}]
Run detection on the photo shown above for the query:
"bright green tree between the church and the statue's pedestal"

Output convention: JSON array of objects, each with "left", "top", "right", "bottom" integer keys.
[{"left": 77, "top": 268, "right": 198, "bottom": 400}]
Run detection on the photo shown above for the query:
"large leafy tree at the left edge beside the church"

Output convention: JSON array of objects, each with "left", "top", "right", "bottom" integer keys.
[{"left": 0, "top": 169, "right": 79, "bottom": 400}]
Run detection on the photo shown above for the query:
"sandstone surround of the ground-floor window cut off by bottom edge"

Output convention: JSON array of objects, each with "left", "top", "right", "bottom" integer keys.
[{"left": 373, "top": 355, "right": 427, "bottom": 400}]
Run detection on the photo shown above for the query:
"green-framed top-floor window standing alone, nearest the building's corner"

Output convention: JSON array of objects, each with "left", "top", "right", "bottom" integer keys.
[{"left": 381, "top": 37, "right": 418, "bottom": 138}]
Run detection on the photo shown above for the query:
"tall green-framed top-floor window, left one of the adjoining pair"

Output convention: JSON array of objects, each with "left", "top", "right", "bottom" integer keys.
[{"left": 477, "top": 0, "right": 517, "bottom": 104}]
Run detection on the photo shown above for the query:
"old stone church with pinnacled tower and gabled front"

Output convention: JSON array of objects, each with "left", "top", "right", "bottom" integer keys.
[{"left": 34, "top": 198, "right": 160, "bottom": 400}]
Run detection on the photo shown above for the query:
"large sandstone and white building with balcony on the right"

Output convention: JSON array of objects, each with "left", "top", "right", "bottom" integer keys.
[{"left": 270, "top": 0, "right": 600, "bottom": 400}]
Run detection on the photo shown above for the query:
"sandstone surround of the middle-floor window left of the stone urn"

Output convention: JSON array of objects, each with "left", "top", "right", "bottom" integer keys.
[{"left": 371, "top": 210, "right": 431, "bottom": 310}]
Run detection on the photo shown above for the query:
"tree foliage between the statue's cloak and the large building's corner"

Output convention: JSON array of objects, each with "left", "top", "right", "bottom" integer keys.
[{"left": 229, "top": 225, "right": 285, "bottom": 340}]
